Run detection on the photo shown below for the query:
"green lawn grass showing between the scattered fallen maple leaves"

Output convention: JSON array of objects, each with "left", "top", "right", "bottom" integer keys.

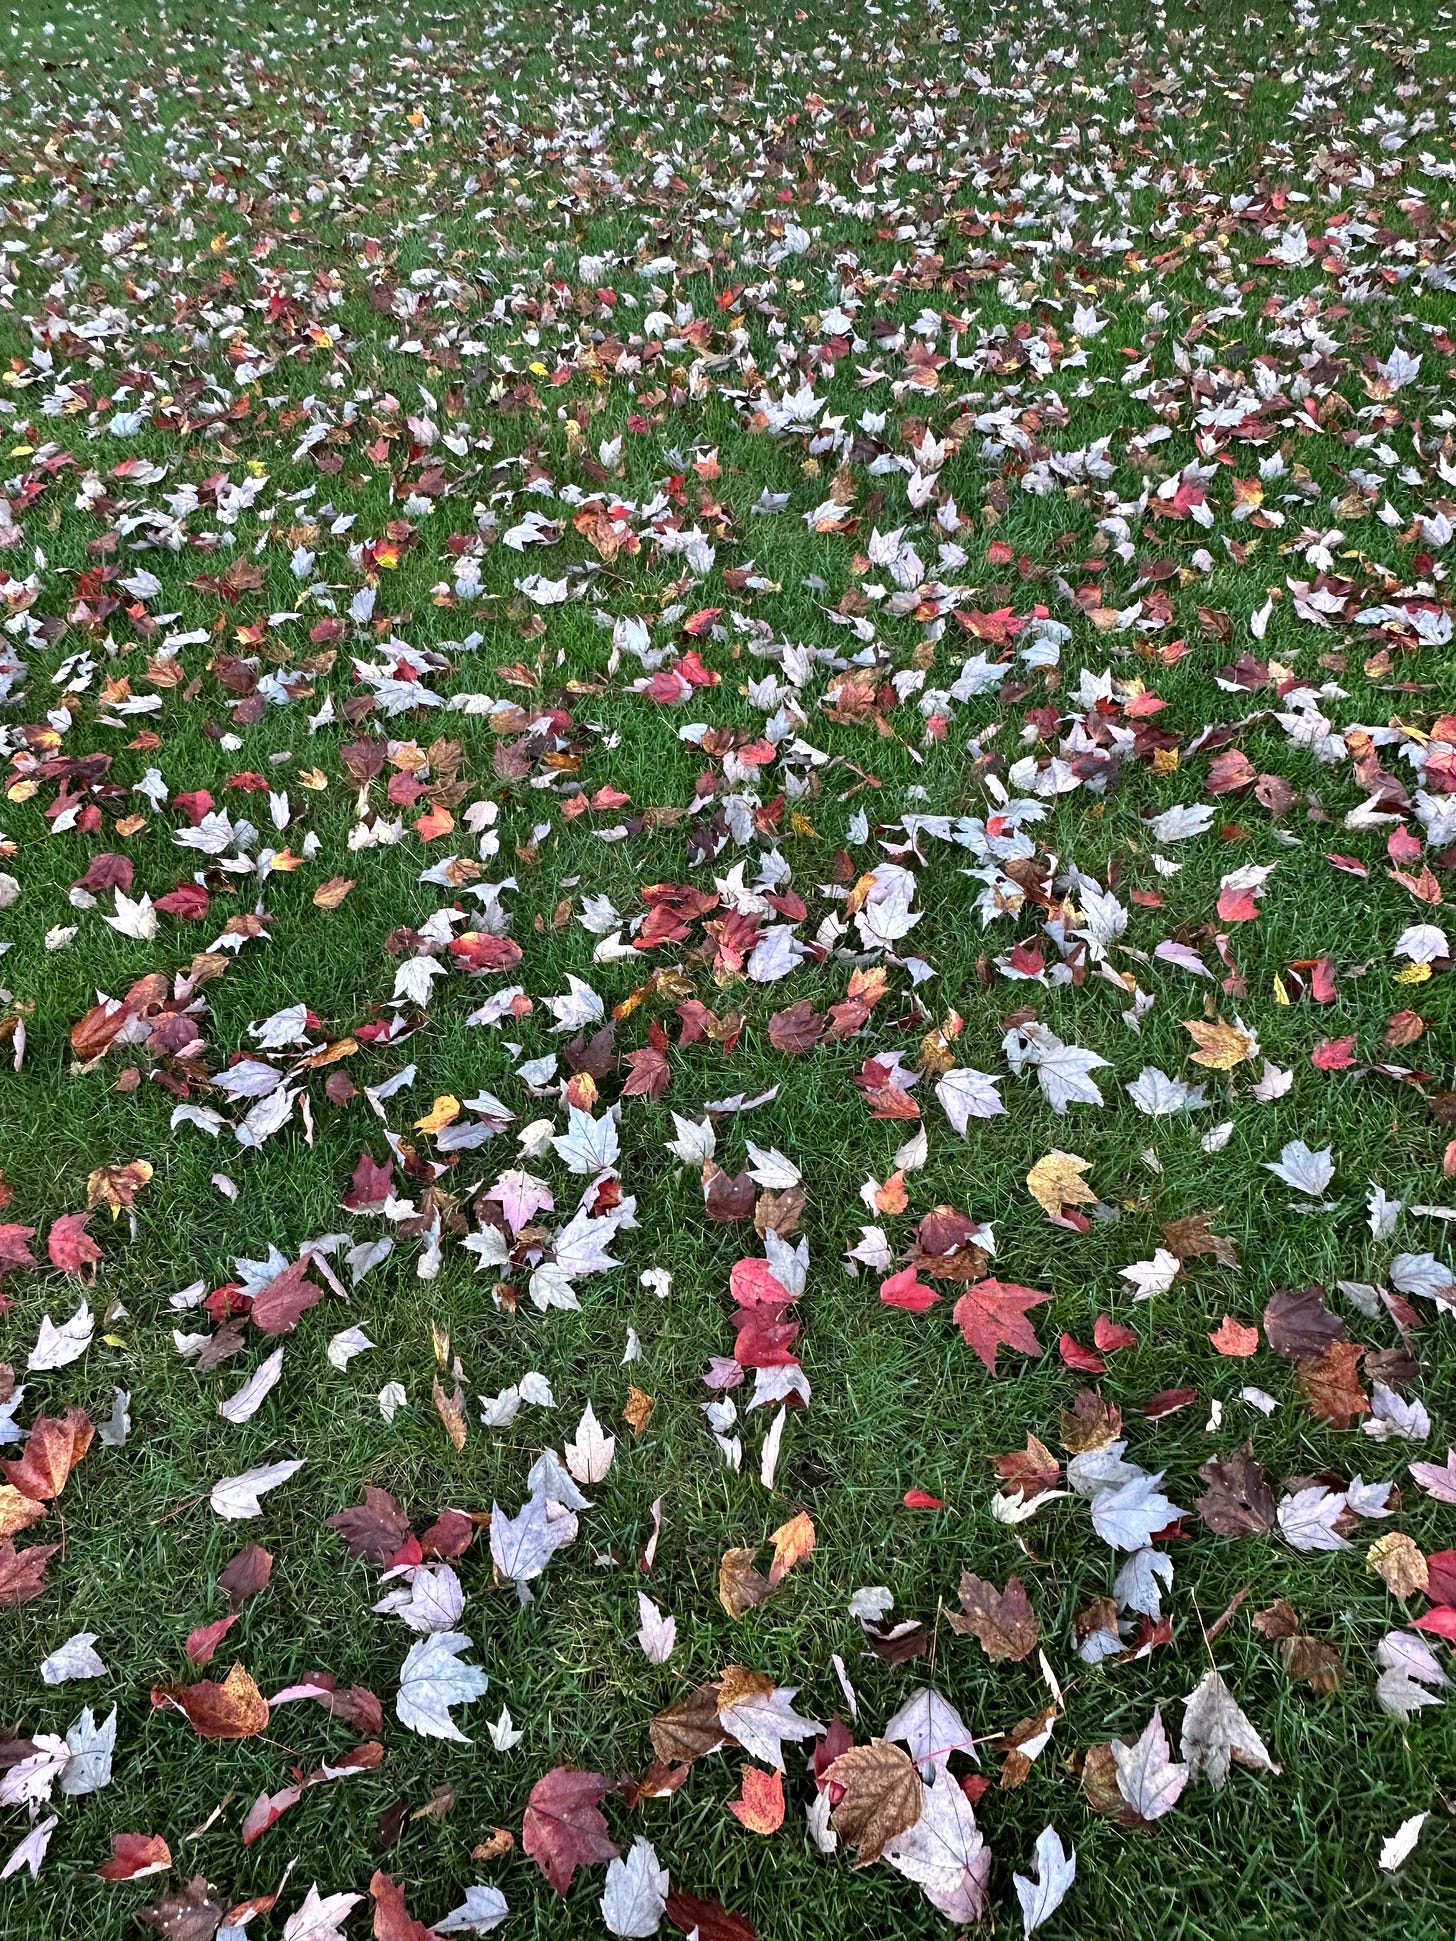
[{"left": 0, "top": 0, "right": 1456, "bottom": 1941}]
